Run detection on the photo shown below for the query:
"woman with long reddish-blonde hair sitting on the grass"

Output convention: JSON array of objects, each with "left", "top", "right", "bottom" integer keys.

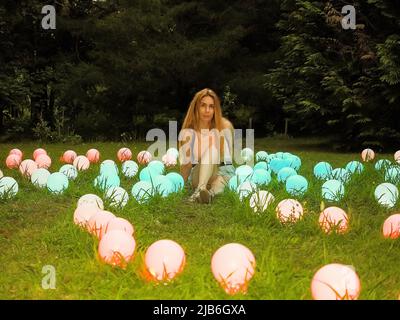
[{"left": 179, "top": 89, "right": 235, "bottom": 203}]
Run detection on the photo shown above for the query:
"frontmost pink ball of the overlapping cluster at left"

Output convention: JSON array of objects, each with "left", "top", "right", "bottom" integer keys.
[{"left": 98, "top": 230, "right": 136, "bottom": 268}]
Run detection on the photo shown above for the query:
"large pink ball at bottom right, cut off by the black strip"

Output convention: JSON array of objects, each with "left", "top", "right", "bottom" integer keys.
[{"left": 311, "top": 263, "right": 361, "bottom": 300}]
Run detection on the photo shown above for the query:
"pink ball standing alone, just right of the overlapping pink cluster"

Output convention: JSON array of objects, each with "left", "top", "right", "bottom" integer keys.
[{"left": 145, "top": 240, "right": 186, "bottom": 281}]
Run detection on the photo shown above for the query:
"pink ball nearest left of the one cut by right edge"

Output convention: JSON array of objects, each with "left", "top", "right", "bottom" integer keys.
[{"left": 319, "top": 207, "right": 349, "bottom": 233}]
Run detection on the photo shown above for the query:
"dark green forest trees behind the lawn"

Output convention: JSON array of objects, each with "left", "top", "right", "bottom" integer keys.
[{"left": 0, "top": 0, "right": 400, "bottom": 150}]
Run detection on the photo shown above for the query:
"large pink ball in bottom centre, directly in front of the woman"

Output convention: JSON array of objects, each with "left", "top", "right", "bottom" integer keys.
[{"left": 211, "top": 243, "right": 256, "bottom": 295}]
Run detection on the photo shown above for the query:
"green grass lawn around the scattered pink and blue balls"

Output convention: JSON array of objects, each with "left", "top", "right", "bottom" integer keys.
[{"left": 0, "top": 139, "right": 400, "bottom": 300}]
